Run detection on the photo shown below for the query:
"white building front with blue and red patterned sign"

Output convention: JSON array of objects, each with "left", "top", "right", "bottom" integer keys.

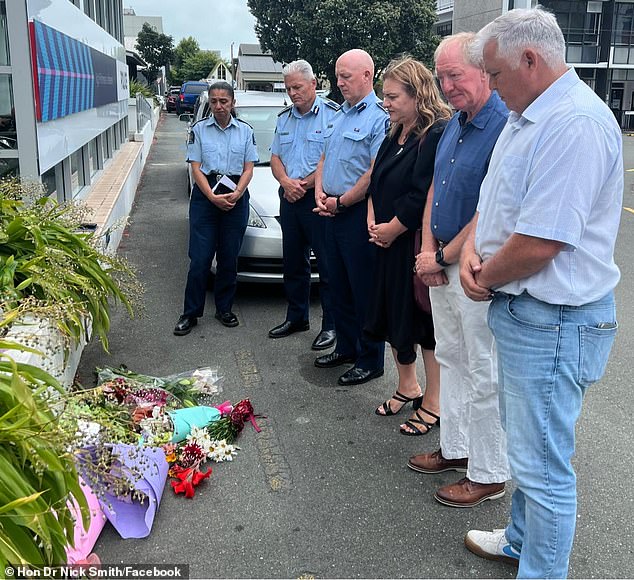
[{"left": 0, "top": 0, "right": 129, "bottom": 201}]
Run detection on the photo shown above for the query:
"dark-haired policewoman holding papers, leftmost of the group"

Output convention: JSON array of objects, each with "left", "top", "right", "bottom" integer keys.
[{"left": 174, "top": 82, "right": 258, "bottom": 336}]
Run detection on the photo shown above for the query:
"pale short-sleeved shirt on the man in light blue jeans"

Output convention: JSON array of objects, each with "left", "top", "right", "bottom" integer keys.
[{"left": 476, "top": 69, "right": 623, "bottom": 306}]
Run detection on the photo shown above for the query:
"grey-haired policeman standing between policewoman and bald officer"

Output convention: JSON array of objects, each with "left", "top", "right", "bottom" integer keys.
[{"left": 269, "top": 60, "right": 339, "bottom": 350}]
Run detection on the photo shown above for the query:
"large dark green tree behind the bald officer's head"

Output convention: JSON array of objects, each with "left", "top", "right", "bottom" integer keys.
[{"left": 247, "top": 0, "right": 439, "bottom": 102}]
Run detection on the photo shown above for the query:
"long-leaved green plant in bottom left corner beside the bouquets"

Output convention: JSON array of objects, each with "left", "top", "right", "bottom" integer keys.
[{"left": 0, "top": 338, "right": 89, "bottom": 570}]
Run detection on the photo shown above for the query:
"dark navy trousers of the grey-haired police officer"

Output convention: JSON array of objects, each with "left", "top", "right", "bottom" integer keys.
[{"left": 279, "top": 188, "right": 335, "bottom": 330}]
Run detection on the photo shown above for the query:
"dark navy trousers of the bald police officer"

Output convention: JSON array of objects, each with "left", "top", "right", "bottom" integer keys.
[{"left": 320, "top": 201, "right": 385, "bottom": 370}]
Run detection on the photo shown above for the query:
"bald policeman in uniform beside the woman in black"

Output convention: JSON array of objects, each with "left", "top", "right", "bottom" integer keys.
[{"left": 315, "top": 49, "right": 389, "bottom": 386}]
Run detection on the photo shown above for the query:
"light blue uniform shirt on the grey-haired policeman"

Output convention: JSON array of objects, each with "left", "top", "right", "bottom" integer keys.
[{"left": 271, "top": 96, "right": 340, "bottom": 179}]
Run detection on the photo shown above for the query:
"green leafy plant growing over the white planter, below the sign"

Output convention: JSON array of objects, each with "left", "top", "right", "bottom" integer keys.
[{"left": 0, "top": 180, "right": 139, "bottom": 350}]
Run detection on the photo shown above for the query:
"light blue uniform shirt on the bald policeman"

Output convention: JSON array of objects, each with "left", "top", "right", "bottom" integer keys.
[{"left": 322, "top": 91, "right": 390, "bottom": 196}]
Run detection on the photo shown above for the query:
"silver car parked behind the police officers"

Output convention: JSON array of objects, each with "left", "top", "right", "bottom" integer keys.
[{"left": 180, "top": 91, "right": 318, "bottom": 282}]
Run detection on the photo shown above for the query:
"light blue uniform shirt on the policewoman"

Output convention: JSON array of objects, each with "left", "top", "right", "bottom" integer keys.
[{"left": 187, "top": 116, "right": 258, "bottom": 175}]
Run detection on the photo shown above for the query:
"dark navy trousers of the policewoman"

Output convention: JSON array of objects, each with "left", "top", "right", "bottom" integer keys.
[{"left": 183, "top": 185, "right": 249, "bottom": 318}]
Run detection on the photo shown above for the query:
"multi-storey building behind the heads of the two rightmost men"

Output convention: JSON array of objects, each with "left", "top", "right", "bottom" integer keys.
[{"left": 436, "top": 0, "right": 634, "bottom": 130}]
